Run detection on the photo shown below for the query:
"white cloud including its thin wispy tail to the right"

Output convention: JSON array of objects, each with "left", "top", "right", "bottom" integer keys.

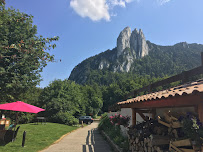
[{"left": 70, "top": 0, "right": 133, "bottom": 21}]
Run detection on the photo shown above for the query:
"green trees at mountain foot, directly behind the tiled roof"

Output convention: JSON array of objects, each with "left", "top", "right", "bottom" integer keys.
[{"left": 98, "top": 72, "right": 163, "bottom": 111}]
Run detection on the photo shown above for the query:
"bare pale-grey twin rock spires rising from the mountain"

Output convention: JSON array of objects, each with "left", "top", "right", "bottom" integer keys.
[{"left": 104, "top": 27, "right": 149, "bottom": 72}]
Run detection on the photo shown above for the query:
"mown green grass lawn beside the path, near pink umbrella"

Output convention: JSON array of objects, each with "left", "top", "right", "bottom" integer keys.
[{"left": 0, "top": 123, "right": 78, "bottom": 152}]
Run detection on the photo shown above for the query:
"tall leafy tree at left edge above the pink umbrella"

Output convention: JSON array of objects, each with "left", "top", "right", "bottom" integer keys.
[{"left": 0, "top": 3, "right": 58, "bottom": 102}]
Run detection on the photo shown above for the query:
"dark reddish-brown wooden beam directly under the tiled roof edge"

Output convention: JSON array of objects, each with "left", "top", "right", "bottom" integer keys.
[{"left": 120, "top": 93, "right": 203, "bottom": 109}]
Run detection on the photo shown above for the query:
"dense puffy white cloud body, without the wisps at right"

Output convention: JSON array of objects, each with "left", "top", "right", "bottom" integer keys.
[{"left": 70, "top": 0, "right": 110, "bottom": 21}]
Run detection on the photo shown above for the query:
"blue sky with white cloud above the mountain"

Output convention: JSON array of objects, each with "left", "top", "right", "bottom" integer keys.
[{"left": 6, "top": 0, "right": 203, "bottom": 88}]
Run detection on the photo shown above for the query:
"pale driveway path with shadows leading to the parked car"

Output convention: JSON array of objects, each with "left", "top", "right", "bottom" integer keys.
[{"left": 41, "top": 122, "right": 111, "bottom": 152}]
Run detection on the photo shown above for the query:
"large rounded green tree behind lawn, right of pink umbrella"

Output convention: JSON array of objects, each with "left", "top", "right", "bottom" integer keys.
[{"left": 39, "top": 80, "right": 85, "bottom": 118}]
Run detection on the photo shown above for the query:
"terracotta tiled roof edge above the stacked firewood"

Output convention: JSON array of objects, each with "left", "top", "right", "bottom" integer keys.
[{"left": 117, "top": 79, "right": 203, "bottom": 105}]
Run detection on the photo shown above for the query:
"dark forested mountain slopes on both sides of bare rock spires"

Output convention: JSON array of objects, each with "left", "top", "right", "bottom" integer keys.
[{"left": 69, "top": 41, "right": 203, "bottom": 85}]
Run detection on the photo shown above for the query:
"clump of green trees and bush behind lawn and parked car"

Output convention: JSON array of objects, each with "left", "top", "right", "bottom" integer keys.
[{"left": 38, "top": 80, "right": 103, "bottom": 124}]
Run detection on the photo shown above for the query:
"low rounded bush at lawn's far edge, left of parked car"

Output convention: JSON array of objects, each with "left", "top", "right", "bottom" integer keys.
[{"left": 52, "top": 111, "right": 79, "bottom": 125}]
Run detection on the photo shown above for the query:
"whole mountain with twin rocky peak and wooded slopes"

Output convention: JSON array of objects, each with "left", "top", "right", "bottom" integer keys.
[{"left": 69, "top": 27, "right": 203, "bottom": 85}]
